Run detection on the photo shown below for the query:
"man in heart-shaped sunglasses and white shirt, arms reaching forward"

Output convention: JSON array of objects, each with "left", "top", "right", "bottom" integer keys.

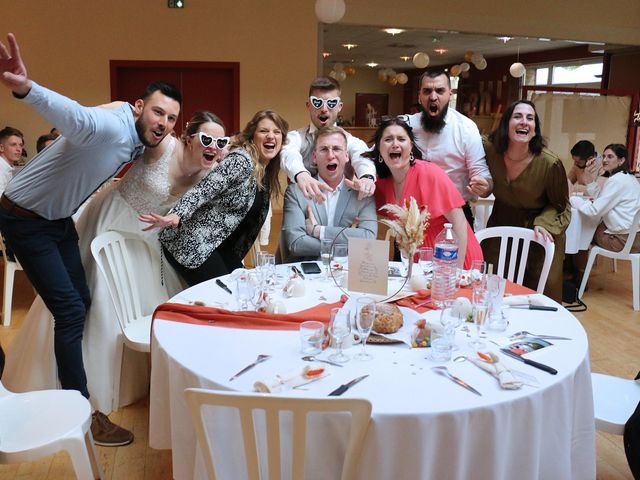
[{"left": 281, "top": 77, "right": 376, "bottom": 203}]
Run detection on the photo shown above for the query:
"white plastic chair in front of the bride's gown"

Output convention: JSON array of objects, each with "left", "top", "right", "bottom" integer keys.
[{"left": 91, "top": 231, "right": 154, "bottom": 406}]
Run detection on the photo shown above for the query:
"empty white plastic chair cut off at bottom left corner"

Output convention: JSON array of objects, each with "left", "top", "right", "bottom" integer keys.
[{"left": 0, "top": 382, "right": 103, "bottom": 480}]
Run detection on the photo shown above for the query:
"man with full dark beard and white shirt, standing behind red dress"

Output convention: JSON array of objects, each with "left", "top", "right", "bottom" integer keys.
[{"left": 408, "top": 70, "right": 493, "bottom": 227}]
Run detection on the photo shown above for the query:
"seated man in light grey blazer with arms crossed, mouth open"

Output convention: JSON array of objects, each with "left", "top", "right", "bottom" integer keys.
[{"left": 280, "top": 126, "right": 378, "bottom": 263}]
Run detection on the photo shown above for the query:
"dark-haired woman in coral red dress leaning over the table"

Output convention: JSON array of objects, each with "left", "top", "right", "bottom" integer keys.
[{"left": 366, "top": 118, "right": 482, "bottom": 270}]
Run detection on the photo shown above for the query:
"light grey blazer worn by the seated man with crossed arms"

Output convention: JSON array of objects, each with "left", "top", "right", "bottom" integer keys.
[{"left": 280, "top": 179, "right": 378, "bottom": 263}]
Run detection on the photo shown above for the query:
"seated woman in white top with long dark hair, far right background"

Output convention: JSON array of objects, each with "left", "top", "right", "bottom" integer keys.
[{"left": 571, "top": 143, "right": 640, "bottom": 281}]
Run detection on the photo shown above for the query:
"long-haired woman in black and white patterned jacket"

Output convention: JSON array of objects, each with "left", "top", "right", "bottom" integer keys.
[{"left": 141, "top": 110, "right": 289, "bottom": 285}]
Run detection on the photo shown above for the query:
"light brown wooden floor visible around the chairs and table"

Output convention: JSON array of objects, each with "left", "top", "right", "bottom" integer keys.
[{"left": 0, "top": 260, "right": 640, "bottom": 480}]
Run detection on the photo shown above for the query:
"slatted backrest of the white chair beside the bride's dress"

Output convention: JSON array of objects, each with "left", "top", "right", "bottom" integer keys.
[{"left": 91, "top": 231, "right": 153, "bottom": 342}]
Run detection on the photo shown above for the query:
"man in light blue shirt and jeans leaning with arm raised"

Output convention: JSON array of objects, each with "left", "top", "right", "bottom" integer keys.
[{"left": 0, "top": 34, "right": 182, "bottom": 446}]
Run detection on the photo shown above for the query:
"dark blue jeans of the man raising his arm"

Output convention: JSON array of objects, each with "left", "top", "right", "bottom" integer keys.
[{"left": 0, "top": 208, "right": 91, "bottom": 398}]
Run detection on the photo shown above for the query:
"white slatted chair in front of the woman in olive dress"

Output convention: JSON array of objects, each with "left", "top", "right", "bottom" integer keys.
[{"left": 476, "top": 227, "right": 556, "bottom": 293}]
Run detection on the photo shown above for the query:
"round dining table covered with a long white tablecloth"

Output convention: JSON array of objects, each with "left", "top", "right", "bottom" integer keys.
[{"left": 149, "top": 264, "right": 596, "bottom": 480}]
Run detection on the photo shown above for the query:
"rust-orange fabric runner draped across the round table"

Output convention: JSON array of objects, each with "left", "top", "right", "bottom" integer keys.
[{"left": 153, "top": 282, "right": 536, "bottom": 330}]
